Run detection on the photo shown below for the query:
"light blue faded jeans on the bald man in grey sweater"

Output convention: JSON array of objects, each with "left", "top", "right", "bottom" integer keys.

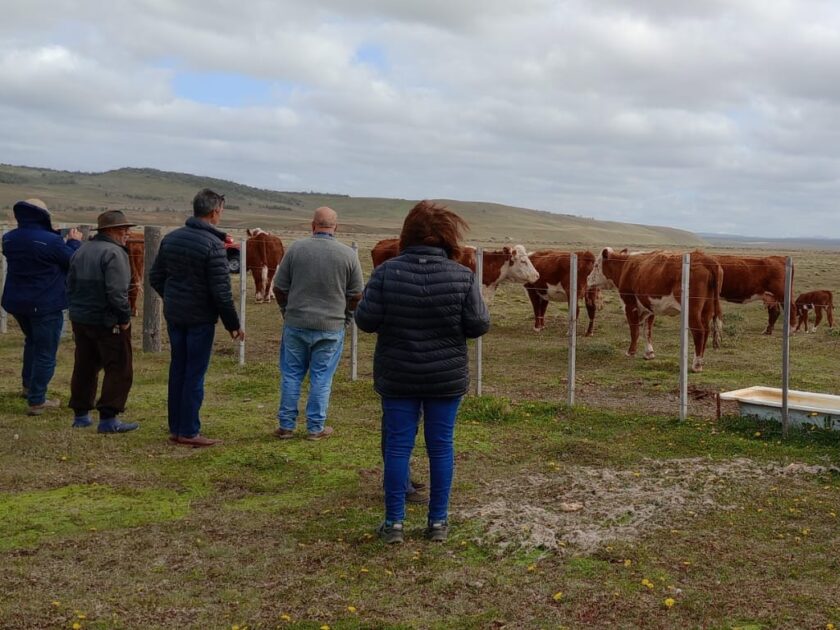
[{"left": 277, "top": 326, "right": 344, "bottom": 433}]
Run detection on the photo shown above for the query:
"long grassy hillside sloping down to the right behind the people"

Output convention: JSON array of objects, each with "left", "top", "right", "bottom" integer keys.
[{"left": 0, "top": 165, "right": 705, "bottom": 247}]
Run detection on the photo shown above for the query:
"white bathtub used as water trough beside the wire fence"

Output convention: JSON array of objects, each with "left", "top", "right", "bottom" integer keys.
[{"left": 720, "top": 386, "right": 840, "bottom": 431}]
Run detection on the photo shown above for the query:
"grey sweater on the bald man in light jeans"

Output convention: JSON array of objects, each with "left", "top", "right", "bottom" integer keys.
[{"left": 274, "top": 233, "right": 364, "bottom": 330}]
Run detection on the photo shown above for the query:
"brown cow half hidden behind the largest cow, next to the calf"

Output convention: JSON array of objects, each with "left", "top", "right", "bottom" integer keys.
[{"left": 715, "top": 255, "right": 796, "bottom": 335}]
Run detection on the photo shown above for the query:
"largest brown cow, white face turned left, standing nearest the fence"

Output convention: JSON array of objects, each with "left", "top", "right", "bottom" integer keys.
[{"left": 587, "top": 247, "right": 724, "bottom": 372}]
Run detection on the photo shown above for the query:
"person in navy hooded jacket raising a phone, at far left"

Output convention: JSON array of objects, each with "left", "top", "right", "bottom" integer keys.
[{"left": 2, "top": 199, "right": 82, "bottom": 416}]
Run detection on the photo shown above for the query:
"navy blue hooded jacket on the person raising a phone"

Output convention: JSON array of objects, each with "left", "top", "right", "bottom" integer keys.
[{"left": 2, "top": 201, "right": 81, "bottom": 315}]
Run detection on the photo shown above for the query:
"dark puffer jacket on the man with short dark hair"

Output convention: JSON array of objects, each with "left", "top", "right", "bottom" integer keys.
[{"left": 149, "top": 217, "right": 239, "bottom": 330}]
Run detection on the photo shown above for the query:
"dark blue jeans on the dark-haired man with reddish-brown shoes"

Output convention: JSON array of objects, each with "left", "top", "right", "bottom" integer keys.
[{"left": 166, "top": 324, "right": 216, "bottom": 437}]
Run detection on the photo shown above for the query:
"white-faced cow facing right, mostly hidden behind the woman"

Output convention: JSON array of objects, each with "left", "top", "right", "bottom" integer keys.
[{"left": 370, "top": 238, "right": 540, "bottom": 304}]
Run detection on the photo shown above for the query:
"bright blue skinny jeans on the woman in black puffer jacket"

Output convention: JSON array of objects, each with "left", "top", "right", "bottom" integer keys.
[{"left": 382, "top": 397, "right": 461, "bottom": 523}]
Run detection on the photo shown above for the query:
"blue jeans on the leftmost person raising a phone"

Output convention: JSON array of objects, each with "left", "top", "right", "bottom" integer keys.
[{"left": 14, "top": 311, "right": 64, "bottom": 405}]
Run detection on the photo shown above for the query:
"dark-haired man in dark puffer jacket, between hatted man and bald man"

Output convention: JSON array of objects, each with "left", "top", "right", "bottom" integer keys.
[{"left": 149, "top": 188, "right": 245, "bottom": 448}]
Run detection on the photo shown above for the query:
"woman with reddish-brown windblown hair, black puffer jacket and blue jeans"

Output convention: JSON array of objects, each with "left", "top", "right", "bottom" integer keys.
[{"left": 356, "top": 201, "right": 490, "bottom": 543}]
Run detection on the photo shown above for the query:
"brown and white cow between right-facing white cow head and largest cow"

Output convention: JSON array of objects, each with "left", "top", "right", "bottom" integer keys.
[{"left": 525, "top": 249, "right": 602, "bottom": 337}]
